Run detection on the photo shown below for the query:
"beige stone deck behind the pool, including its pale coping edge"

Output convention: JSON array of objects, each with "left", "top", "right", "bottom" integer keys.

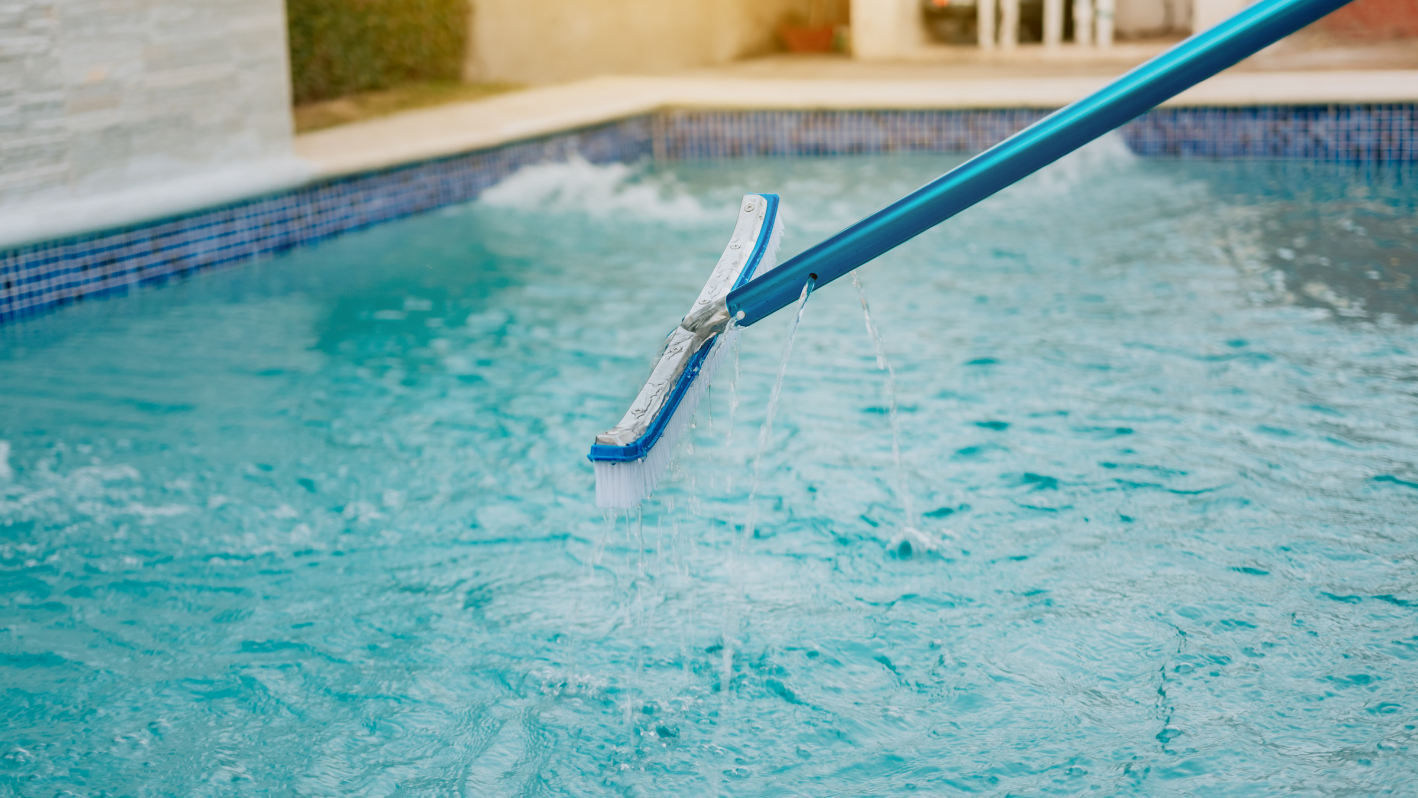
[{"left": 295, "top": 43, "right": 1418, "bottom": 176}]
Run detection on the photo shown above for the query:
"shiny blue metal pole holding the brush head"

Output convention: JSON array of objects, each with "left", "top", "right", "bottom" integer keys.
[{"left": 727, "top": 0, "right": 1349, "bottom": 327}]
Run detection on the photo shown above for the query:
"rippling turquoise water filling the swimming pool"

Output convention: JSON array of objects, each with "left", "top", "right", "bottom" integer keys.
[{"left": 0, "top": 142, "right": 1418, "bottom": 797}]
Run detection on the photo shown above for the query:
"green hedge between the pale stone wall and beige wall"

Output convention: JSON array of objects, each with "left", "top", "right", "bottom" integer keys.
[{"left": 285, "top": 0, "right": 468, "bottom": 103}]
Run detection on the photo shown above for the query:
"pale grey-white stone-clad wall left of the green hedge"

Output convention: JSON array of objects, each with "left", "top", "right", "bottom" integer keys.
[{"left": 0, "top": 0, "right": 292, "bottom": 217}]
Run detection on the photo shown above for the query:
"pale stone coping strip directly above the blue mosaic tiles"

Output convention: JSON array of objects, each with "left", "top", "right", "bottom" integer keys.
[{"left": 295, "top": 69, "right": 1418, "bottom": 179}]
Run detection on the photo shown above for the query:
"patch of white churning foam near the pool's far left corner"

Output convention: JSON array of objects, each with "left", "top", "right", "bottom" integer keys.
[{"left": 478, "top": 154, "right": 712, "bottom": 221}]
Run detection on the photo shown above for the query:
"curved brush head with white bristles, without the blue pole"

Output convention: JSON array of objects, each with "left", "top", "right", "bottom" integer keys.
[{"left": 587, "top": 194, "right": 783, "bottom": 509}]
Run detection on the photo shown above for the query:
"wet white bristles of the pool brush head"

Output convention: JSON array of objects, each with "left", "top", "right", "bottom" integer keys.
[{"left": 594, "top": 210, "right": 784, "bottom": 510}]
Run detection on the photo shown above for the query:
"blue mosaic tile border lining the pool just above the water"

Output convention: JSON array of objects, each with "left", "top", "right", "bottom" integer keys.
[{"left": 0, "top": 103, "right": 1418, "bottom": 323}]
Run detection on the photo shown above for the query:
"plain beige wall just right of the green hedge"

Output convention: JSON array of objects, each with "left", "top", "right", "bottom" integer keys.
[{"left": 464, "top": 0, "right": 834, "bottom": 84}]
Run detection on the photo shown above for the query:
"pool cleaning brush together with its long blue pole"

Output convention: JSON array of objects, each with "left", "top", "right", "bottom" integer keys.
[{"left": 590, "top": 0, "right": 1350, "bottom": 507}]
